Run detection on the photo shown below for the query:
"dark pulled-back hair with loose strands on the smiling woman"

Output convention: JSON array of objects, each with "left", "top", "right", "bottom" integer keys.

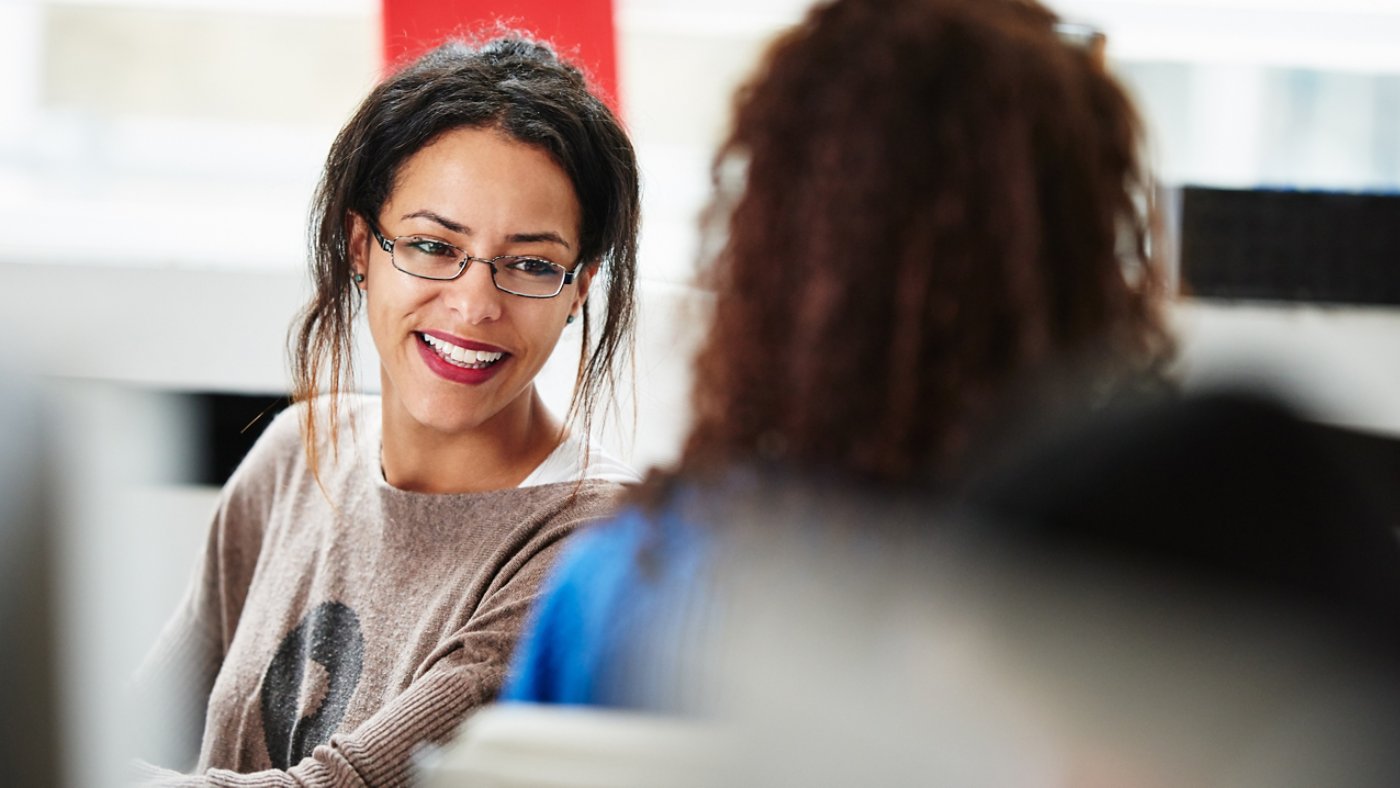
[{"left": 291, "top": 35, "right": 640, "bottom": 469}]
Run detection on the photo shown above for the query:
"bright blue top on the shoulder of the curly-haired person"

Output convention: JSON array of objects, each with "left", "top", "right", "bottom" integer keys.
[{"left": 501, "top": 508, "right": 706, "bottom": 707}]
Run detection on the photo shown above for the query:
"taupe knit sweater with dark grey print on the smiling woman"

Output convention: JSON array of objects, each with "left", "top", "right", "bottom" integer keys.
[{"left": 137, "top": 399, "right": 620, "bottom": 787}]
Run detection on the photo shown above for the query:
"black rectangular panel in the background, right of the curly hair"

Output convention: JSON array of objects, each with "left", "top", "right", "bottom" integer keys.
[{"left": 1180, "top": 186, "right": 1400, "bottom": 305}]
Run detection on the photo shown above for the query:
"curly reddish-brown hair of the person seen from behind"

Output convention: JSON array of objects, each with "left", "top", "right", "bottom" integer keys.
[{"left": 682, "top": 0, "right": 1169, "bottom": 481}]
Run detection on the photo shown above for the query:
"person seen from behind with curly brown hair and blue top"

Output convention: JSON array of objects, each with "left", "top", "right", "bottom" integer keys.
[{"left": 505, "top": 0, "right": 1170, "bottom": 708}]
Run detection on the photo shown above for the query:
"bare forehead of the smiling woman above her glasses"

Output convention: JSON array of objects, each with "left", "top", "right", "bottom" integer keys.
[{"left": 384, "top": 129, "right": 582, "bottom": 242}]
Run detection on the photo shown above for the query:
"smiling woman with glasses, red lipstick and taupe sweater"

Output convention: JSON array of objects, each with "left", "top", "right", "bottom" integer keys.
[{"left": 141, "top": 38, "right": 638, "bottom": 785}]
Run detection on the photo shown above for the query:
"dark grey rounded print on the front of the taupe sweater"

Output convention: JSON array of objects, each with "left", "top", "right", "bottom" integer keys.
[{"left": 260, "top": 602, "right": 364, "bottom": 768}]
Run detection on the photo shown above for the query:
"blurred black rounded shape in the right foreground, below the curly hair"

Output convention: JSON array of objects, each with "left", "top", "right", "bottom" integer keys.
[{"left": 972, "top": 392, "right": 1400, "bottom": 651}]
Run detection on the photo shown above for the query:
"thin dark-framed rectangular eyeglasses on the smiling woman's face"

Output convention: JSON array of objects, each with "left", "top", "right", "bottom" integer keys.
[{"left": 370, "top": 224, "right": 581, "bottom": 298}]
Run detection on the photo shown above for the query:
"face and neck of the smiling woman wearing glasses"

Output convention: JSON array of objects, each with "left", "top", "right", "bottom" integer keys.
[{"left": 350, "top": 127, "right": 595, "bottom": 493}]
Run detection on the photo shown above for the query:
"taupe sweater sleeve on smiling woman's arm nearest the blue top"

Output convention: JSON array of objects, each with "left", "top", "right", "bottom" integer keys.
[{"left": 143, "top": 487, "right": 607, "bottom": 788}]
